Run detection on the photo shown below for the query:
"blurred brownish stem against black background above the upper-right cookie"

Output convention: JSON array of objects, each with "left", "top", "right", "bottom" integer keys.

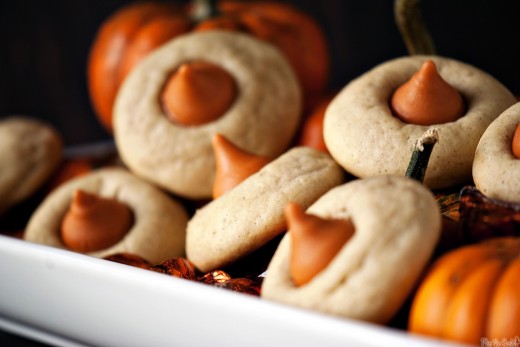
[{"left": 394, "top": 0, "right": 435, "bottom": 55}]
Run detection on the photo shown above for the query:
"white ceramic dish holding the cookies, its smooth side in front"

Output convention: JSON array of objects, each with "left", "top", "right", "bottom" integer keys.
[{"left": 0, "top": 235, "right": 468, "bottom": 347}]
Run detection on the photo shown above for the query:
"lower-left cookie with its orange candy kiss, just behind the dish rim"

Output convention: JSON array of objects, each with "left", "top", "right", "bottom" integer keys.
[{"left": 24, "top": 168, "right": 188, "bottom": 263}]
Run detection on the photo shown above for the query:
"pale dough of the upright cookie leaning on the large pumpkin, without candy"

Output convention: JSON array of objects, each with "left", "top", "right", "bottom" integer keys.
[{"left": 114, "top": 31, "right": 302, "bottom": 199}]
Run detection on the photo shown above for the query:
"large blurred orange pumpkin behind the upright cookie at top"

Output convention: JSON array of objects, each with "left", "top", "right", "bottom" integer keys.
[{"left": 87, "top": 0, "right": 329, "bottom": 132}]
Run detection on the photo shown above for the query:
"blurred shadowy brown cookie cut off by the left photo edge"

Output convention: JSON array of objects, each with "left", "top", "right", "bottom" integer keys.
[{"left": 0, "top": 116, "right": 62, "bottom": 214}]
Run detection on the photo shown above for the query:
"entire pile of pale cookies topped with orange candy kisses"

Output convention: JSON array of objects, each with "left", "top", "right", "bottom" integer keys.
[{"left": 0, "top": 3, "right": 520, "bottom": 347}]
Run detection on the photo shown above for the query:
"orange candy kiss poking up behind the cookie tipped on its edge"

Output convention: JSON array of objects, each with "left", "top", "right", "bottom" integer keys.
[{"left": 212, "top": 134, "right": 271, "bottom": 199}]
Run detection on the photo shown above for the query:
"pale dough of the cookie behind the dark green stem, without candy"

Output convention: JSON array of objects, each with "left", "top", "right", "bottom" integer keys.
[{"left": 324, "top": 56, "right": 516, "bottom": 189}]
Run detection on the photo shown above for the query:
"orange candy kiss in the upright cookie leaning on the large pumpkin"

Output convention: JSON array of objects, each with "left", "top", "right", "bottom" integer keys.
[{"left": 161, "top": 61, "right": 237, "bottom": 126}]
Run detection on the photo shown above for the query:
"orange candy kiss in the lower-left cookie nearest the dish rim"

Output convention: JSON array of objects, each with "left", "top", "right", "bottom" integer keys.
[{"left": 61, "top": 189, "right": 133, "bottom": 253}]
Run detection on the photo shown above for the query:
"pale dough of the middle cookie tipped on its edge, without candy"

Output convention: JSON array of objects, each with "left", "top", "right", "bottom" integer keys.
[{"left": 186, "top": 147, "right": 344, "bottom": 271}]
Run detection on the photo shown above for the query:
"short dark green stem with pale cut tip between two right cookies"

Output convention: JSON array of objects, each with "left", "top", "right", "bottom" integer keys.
[{"left": 406, "top": 128, "right": 439, "bottom": 182}]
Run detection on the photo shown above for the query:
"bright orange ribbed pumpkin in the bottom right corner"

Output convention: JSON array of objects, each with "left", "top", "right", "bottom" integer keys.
[{"left": 409, "top": 237, "right": 520, "bottom": 345}]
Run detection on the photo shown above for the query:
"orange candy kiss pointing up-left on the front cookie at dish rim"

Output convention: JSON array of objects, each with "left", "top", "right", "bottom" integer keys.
[{"left": 285, "top": 203, "right": 355, "bottom": 286}]
